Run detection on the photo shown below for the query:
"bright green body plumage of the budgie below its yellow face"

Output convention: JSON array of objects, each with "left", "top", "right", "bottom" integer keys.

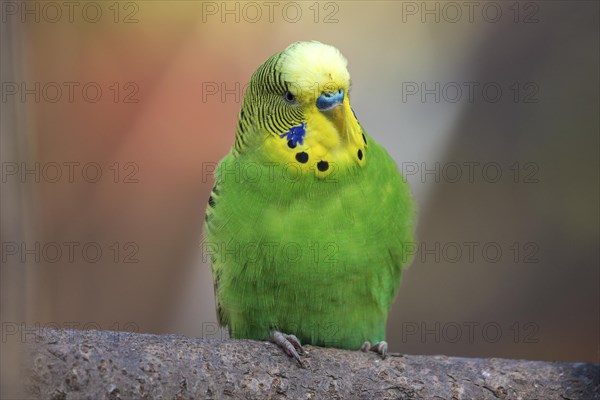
[{"left": 204, "top": 42, "right": 414, "bottom": 349}]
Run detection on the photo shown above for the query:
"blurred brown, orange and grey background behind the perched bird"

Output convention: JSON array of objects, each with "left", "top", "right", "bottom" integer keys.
[{"left": 0, "top": 1, "right": 600, "bottom": 390}]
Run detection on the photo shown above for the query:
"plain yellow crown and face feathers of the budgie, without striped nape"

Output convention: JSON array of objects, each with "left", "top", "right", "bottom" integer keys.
[{"left": 264, "top": 42, "right": 367, "bottom": 177}]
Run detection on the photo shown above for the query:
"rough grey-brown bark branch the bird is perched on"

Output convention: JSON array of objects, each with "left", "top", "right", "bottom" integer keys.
[{"left": 25, "top": 329, "right": 600, "bottom": 400}]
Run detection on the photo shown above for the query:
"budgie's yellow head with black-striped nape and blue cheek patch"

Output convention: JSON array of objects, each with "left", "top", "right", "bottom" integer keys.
[{"left": 236, "top": 42, "right": 366, "bottom": 177}]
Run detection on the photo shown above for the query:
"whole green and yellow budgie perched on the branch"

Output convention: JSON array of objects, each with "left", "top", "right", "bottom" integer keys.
[{"left": 204, "top": 42, "right": 414, "bottom": 365}]
